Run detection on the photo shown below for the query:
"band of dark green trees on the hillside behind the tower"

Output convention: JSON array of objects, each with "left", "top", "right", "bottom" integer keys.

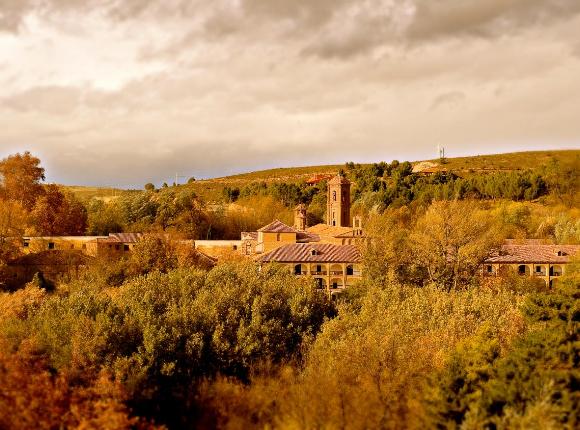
[{"left": 223, "top": 160, "right": 580, "bottom": 212}]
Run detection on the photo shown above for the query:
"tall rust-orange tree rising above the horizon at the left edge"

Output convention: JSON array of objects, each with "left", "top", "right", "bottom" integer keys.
[{"left": 0, "top": 151, "right": 45, "bottom": 210}]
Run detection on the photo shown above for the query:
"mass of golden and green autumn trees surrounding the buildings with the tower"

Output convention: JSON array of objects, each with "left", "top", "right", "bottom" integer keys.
[{"left": 0, "top": 154, "right": 580, "bottom": 429}]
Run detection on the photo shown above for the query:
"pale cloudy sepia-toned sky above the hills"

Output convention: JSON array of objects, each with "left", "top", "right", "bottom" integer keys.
[{"left": 0, "top": 0, "right": 580, "bottom": 186}]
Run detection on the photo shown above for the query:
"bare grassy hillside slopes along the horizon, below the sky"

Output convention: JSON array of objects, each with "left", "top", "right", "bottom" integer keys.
[{"left": 61, "top": 150, "right": 580, "bottom": 202}]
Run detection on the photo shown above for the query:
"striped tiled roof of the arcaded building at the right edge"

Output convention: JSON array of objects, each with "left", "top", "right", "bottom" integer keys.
[{"left": 485, "top": 243, "right": 580, "bottom": 264}]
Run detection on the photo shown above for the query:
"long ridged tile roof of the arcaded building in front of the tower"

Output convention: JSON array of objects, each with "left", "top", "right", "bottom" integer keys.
[{"left": 258, "top": 243, "right": 361, "bottom": 263}]
